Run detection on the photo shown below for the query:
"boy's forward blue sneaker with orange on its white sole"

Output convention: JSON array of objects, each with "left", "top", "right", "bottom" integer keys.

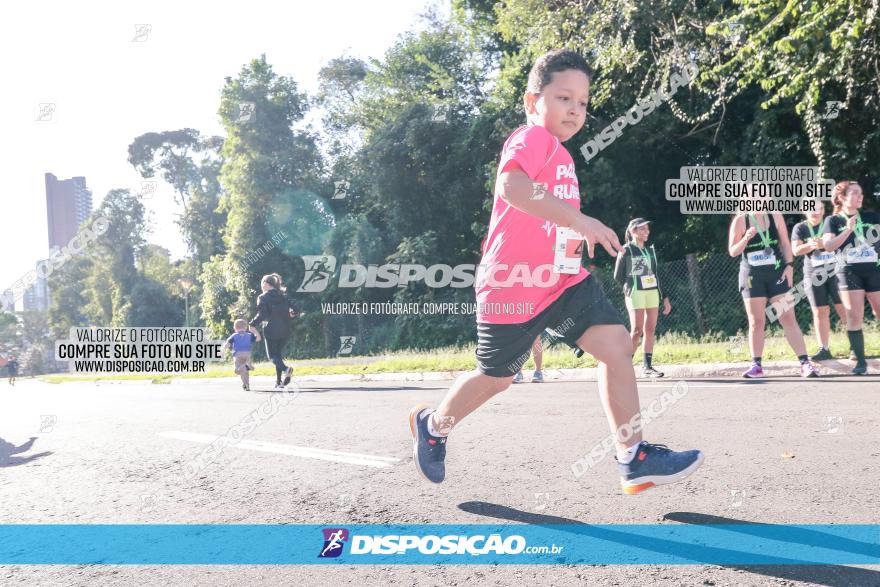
[{"left": 617, "top": 441, "right": 703, "bottom": 495}]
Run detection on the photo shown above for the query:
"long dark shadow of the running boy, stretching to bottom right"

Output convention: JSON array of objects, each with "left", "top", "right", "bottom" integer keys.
[{"left": 458, "top": 501, "right": 880, "bottom": 587}]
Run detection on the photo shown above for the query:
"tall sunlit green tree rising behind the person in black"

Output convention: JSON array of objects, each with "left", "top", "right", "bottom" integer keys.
[{"left": 201, "top": 55, "right": 332, "bottom": 340}]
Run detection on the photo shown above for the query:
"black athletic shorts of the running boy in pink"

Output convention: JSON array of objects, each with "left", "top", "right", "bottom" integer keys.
[{"left": 476, "top": 275, "right": 623, "bottom": 377}]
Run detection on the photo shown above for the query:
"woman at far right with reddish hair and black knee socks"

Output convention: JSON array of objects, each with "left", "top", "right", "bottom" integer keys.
[{"left": 822, "top": 181, "right": 880, "bottom": 375}]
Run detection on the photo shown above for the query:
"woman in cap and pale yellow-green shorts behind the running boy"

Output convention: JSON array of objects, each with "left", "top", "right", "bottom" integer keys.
[{"left": 614, "top": 218, "right": 672, "bottom": 377}]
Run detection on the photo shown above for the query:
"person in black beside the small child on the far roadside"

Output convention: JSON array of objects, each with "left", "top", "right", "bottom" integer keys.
[{"left": 250, "top": 273, "right": 295, "bottom": 389}]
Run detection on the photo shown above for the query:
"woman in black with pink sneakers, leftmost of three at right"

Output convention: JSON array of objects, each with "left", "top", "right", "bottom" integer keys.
[{"left": 727, "top": 202, "right": 819, "bottom": 378}]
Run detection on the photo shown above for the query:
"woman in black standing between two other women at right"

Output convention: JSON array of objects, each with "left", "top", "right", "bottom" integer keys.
[{"left": 791, "top": 204, "right": 846, "bottom": 361}]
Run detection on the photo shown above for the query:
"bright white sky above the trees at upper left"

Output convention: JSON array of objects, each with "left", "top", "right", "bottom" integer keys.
[{"left": 0, "top": 0, "right": 436, "bottom": 291}]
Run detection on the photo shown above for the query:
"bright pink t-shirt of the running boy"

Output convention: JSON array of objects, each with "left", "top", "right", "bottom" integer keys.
[{"left": 475, "top": 125, "right": 589, "bottom": 324}]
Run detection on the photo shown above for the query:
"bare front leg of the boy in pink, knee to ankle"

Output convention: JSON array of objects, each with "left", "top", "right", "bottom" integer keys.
[{"left": 578, "top": 324, "right": 642, "bottom": 449}]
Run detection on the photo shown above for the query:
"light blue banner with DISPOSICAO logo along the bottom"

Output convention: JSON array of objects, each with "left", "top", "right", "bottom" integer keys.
[{"left": 0, "top": 523, "right": 880, "bottom": 565}]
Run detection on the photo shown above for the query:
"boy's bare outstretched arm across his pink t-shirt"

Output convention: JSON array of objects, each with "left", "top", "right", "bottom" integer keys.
[{"left": 495, "top": 162, "right": 623, "bottom": 258}]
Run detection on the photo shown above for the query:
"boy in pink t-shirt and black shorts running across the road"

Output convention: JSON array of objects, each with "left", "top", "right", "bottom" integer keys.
[{"left": 409, "top": 50, "right": 703, "bottom": 494}]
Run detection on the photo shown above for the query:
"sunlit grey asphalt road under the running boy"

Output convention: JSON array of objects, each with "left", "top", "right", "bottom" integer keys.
[{"left": 0, "top": 377, "right": 880, "bottom": 585}]
